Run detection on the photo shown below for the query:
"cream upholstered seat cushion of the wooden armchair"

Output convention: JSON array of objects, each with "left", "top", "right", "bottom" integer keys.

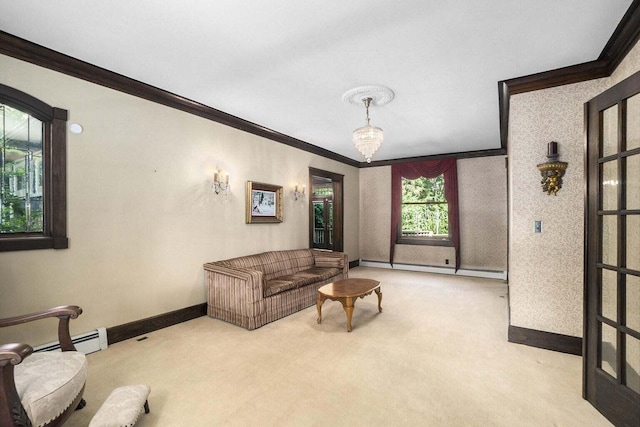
[{"left": 14, "top": 351, "right": 87, "bottom": 426}]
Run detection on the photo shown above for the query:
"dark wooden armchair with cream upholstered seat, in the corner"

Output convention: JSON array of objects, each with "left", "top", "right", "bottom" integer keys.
[{"left": 0, "top": 306, "right": 87, "bottom": 427}]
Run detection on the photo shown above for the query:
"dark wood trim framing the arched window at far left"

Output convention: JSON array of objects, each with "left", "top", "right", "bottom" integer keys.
[{"left": 0, "top": 84, "right": 69, "bottom": 252}]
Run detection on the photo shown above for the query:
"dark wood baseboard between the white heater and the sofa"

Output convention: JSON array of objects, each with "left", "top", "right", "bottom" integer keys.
[{"left": 107, "top": 303, "right": 207, "bottom": 344}]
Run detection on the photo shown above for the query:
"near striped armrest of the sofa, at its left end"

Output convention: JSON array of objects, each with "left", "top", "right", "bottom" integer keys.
[{"left": 204, "top": 262, "right": 264, "bottom": 316}]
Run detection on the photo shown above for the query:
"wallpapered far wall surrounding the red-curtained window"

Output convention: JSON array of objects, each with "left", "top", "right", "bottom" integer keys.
[{"left": 360, "top": 156, "right": 507, "bottom": 271}]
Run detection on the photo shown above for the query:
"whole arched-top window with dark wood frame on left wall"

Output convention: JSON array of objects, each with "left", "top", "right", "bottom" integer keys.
[{"left": 0, "top": 85, "right": 68, "bottom": 251}]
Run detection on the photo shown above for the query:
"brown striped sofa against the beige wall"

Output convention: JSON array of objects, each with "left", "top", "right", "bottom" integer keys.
[{"left": 204, "top": 249, "right": 349, "bottom": 330}]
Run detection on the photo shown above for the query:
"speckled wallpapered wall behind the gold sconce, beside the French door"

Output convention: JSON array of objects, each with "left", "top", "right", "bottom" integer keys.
[{"left": 508, "top": 38, "right": 640, "bottom": 336}]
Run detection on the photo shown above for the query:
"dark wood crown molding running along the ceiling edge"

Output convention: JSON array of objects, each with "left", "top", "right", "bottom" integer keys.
[{"left": 0, "top": 0, "right": 640, "bottom": 168}]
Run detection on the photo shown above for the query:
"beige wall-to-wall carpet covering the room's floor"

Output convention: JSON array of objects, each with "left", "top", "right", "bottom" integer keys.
[{"left": 67, "top": 267, "right": 610, "bottom": 427}]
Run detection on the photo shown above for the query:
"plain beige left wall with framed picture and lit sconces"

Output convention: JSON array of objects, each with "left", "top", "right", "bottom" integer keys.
[{"left": 0, "top": 56, "right": 360, "bottom": 344}]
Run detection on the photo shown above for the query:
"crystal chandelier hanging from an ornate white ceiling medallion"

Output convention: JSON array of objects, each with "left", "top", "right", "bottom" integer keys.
[{"left": 342, "top": 86, "right": 394, "bottom": 163}]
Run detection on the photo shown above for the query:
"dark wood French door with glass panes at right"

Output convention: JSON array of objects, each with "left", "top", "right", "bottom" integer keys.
[{"left": 584, "top": 68, "right": 640, "bottom": 427}]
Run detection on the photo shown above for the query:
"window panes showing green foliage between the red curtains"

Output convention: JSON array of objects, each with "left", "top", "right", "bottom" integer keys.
[{"left": 398, "top": 175, "right": 450, "bottom": 243}]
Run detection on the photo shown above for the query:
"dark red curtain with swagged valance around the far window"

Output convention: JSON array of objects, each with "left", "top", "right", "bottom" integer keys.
[{"left": 389, "top": 159, "right": 460, "bottom": 271}]
